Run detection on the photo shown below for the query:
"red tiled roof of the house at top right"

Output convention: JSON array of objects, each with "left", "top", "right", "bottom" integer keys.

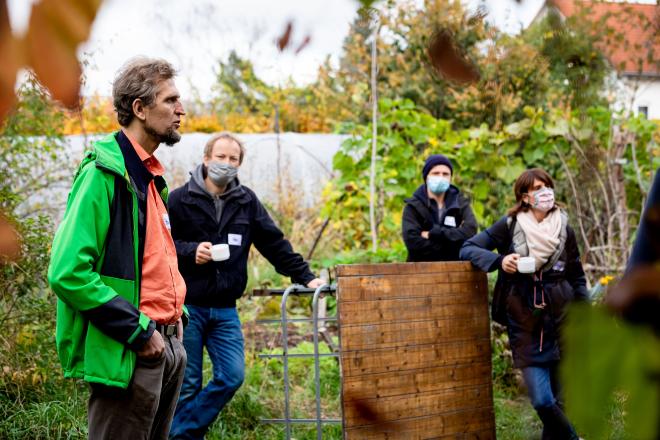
[{"left": 548, "top": 0, "right": 660, "bottom": 75}]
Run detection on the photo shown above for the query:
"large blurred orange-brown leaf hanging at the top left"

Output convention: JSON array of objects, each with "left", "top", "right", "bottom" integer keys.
[{"left": 24, "top": 0, "right": 101, "bottom": 108}]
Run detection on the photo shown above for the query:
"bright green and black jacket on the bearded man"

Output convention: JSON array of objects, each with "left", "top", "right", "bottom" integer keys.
[{"left": 48, "top": 131, "right": 173, "bottom": 388}]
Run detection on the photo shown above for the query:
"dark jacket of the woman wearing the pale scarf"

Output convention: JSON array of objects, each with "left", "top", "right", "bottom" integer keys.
[{"left": 460, "top": 216, "right": 589, "bottom": 368}]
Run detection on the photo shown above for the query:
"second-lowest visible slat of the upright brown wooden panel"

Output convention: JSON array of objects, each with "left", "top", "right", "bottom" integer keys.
[{"left": 344, "top": 384, "right": 492, "bottom": 427}]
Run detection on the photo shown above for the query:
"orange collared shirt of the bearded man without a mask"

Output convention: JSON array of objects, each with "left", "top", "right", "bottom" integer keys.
[{"left": 124, "top": 132, "right": 186, "bottom": 324}]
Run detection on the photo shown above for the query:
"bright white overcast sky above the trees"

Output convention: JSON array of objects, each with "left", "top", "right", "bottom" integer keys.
[{"left": 14, "top": 0, "right": 648, "bottom": 99}]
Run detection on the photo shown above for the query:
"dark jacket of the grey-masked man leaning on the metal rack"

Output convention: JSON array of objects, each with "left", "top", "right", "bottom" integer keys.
[{"left": 169, "top": 179, "right": 314, "bottom": 308}]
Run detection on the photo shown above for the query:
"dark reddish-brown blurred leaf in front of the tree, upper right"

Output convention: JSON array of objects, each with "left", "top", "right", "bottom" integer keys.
[{"left": 427, "top": 29, "right": 479, "bottom": 83}]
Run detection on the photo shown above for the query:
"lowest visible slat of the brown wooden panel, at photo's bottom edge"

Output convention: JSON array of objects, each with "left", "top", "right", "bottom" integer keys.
[{"left": 346, "top": 408, "right": 495, "bottom": 440}]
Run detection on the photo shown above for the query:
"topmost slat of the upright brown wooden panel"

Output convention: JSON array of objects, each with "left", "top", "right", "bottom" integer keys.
[{"left": 337, "top": 261, "right": 476, "bottom": 277}]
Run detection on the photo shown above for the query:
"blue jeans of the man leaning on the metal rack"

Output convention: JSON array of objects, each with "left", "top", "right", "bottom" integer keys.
[{"left": 170, "top": 306, "right": 245, "bottom": 439}]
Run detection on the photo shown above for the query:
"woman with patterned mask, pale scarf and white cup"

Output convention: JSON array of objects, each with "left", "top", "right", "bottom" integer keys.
[{"left": 460, "top": 168, "right": 589, "bottom": 439}]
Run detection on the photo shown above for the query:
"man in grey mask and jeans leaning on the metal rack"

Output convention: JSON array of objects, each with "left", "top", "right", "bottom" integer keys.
[{"left": 169, "top": 133, "right": 323, "bottom": 439}]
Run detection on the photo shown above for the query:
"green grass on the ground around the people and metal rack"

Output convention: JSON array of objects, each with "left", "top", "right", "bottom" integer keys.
[{"left": 0, "top": 350, "right": 628, "bottom": 440}]
